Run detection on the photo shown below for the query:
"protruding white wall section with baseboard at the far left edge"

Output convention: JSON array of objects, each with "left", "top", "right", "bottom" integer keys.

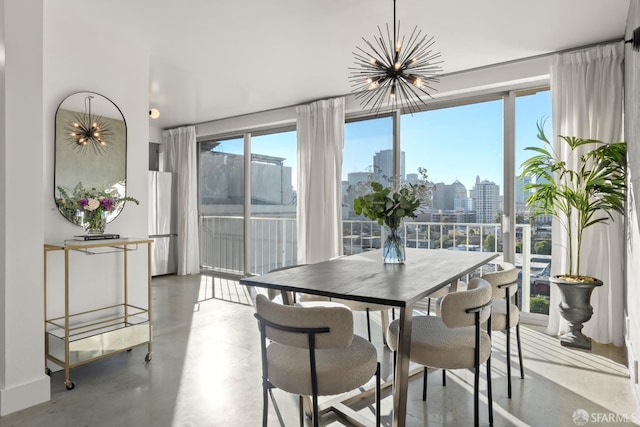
[{"left": 0, "top": 0, "right": 50, "bottom": 415}]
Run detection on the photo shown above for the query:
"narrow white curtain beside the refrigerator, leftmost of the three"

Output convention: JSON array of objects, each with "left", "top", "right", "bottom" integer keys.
[{"left": 162, "top": 126, "right": 200, "bottom": 275}]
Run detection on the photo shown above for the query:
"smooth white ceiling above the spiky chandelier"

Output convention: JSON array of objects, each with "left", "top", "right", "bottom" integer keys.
[{"left": 45, "top": 0, "right": 630, "bottom": 129}]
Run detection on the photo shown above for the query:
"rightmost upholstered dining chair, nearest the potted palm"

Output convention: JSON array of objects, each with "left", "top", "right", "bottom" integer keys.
[{"left": 482, "top": 262, "right": 524, "bottom": 399}]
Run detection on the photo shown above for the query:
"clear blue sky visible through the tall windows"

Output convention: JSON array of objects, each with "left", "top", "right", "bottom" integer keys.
[{"left": 209, "top": 91, "right": 551, "bottom": 197}]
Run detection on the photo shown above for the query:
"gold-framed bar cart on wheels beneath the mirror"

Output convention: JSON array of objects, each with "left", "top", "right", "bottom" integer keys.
[{"left": 44, "top": 239, "right": 152, "bottom": 390}]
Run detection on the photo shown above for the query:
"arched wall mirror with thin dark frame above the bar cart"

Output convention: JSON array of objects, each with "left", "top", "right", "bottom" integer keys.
[{"left": 54, "top": 92, "right": 127, "bottom": 225}]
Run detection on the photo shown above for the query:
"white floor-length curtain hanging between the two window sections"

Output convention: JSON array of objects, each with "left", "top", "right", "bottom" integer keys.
[{"left": 296, "top": 98, "right": 344, "bottom": 264}]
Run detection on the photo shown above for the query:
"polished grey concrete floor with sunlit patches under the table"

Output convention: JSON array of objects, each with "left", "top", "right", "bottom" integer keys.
[{"left": 0, "top": 276, "right": 640, "bottom": 427}]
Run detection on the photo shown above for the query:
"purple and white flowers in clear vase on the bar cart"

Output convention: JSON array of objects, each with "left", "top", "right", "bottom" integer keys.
[{"left": 56, "top": 182, "right": 140, "bottom": 234}]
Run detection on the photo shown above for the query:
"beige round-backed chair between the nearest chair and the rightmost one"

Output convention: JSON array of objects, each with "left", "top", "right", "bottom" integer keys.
[{"left": 387, "top": 278, "right": 493, "bottom": 426}]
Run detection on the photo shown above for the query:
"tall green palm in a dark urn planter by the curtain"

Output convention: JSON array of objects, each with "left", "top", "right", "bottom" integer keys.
[{"left": 522, "top": 121, "right": 627, "bottom": 349}]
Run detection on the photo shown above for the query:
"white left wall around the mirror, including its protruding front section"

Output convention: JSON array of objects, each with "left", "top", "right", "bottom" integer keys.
[{"left": 0, "top": 0, "right": 149, "bottom": 415}]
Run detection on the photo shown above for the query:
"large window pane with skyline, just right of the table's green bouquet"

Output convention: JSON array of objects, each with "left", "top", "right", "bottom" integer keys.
[{"left": 400, "top": 98, "right": 503, "bottom": 252}]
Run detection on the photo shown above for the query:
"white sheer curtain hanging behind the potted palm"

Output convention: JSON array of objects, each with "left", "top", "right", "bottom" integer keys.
[{"left": 547, "top": 43, "right": 625, "bottom": 346}]
